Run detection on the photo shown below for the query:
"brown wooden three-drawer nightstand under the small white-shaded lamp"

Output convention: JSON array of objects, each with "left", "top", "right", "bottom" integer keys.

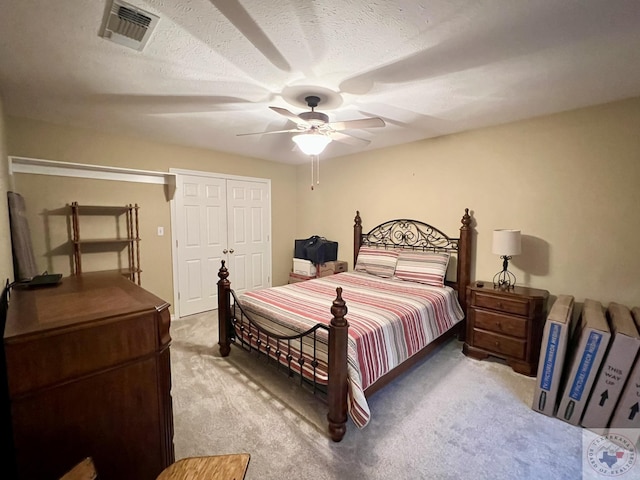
[{"left": 462, "top": 282, "right": 549, "bottom": 377}]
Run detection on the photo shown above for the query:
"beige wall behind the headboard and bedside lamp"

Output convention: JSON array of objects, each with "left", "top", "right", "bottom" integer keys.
[{"left": 297, "top": 98, "right": 640, "bottom": 306}]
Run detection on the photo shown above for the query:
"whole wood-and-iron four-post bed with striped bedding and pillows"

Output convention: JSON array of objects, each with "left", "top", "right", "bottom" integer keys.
[{"left": 218, "top": 209, "right": 472, "bottom": 442}]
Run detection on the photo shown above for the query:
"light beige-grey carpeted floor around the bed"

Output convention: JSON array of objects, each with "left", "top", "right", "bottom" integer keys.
[{"left": 171, "top": 312, "right": 624, "bottom": 480}]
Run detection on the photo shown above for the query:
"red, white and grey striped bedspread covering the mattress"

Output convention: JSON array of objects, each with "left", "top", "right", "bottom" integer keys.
[{"left": 239, "top": 272, "right": 464, "bottom": 428}]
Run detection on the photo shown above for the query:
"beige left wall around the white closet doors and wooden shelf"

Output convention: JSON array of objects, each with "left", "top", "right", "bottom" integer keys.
[{"left": 7, "top": 117, "right": 296, "bottom": 310}]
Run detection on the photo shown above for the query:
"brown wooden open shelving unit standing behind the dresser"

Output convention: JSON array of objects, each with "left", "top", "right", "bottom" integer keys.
[{"left": 71, "top": 202, "right": 142, "bottom": 285}]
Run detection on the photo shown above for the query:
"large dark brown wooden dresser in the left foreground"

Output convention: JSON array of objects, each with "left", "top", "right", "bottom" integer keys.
[{"left": 3, "top": 273, "right": 174, "bottom": 480}]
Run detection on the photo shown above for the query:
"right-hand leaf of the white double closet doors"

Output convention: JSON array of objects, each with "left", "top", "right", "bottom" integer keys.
[{"left": 227, "top": 180, "right": 271, "bottom": 293}]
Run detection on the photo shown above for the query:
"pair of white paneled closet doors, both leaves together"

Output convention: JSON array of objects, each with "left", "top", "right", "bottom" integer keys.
[{"left": 174, "top": 172, "right": 271, "bottom": 317}]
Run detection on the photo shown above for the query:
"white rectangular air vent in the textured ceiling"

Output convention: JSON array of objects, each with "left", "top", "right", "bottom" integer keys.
[{"left": 100, "top": 0, "right": 160, "bottom": 51}]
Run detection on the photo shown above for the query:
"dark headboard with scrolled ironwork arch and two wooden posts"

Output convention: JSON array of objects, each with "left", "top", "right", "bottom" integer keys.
[{"left": 353, "top": 208, "right": 472, "bottom": 314}]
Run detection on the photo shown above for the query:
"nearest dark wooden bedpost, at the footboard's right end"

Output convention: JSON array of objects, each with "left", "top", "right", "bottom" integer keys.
[{"left": 327, "top": 287, "right": 349, "bottom": 442}]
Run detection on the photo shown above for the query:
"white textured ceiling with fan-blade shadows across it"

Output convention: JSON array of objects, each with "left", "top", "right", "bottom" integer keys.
[{"left": 0, "top": 0, "right": 640, "bottom": 163}]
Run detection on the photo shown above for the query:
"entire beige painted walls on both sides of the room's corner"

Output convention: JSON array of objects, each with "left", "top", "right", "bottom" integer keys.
[{"left": 6, "top": 98, "right": 640, "bottom": 312}]
